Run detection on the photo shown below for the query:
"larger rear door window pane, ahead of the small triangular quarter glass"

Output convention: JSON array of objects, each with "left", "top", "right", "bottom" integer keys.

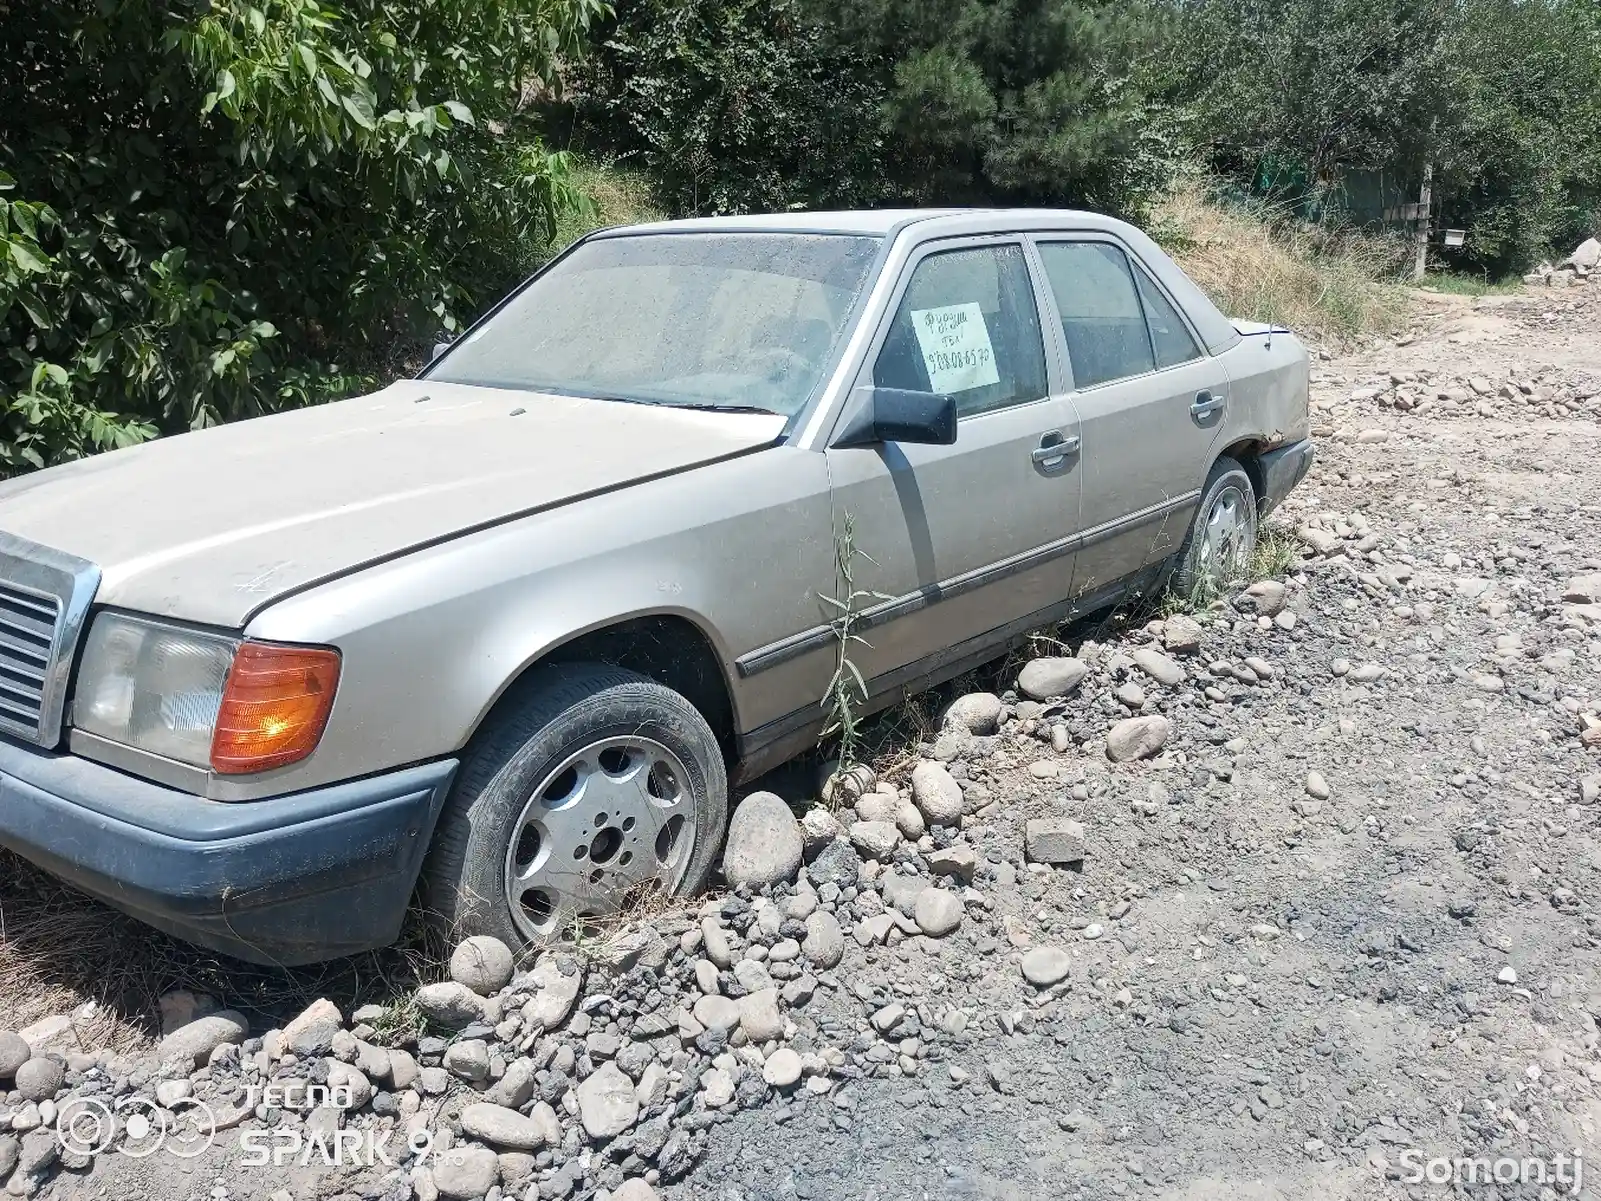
[{"left": 1039, "top": 242, "right": 1156, "bottom": 388}]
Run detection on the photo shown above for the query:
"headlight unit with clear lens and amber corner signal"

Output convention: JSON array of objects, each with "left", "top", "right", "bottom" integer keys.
[{"left": 74, "top": 613, "right": 339, "bottom": 775}]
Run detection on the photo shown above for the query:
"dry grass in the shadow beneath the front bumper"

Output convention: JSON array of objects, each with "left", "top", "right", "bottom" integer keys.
[{"left": 0, "top": 850, "right": 448, "bottom": 1050}]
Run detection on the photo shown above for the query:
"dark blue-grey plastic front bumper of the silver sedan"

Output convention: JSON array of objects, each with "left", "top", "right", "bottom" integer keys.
[{"left": 0, "top": 740, "right": 456, "bottom": 967}]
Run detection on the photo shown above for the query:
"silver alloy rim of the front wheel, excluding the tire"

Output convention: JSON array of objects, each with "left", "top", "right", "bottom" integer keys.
[{"left": 506, "top": 735, "right": 695, "bottom": 942}]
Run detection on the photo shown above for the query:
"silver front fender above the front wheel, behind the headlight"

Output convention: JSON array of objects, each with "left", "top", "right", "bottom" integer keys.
[{"left": 238, "top": 447, "right": 833, "bottom": 799}]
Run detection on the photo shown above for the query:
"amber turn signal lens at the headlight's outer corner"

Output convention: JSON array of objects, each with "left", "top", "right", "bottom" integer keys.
[{"left": 211, "top": 642, "right": 339, "bottom": 775}]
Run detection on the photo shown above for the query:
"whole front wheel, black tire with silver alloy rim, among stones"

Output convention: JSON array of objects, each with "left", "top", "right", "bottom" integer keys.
[{"left": 423, "top": 663, "right": 728, "bottom": 948}]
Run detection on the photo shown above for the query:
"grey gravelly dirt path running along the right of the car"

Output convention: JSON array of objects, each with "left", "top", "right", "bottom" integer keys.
[{"left": 688, "top": 287, "right": 1601, "bottom": 1201}]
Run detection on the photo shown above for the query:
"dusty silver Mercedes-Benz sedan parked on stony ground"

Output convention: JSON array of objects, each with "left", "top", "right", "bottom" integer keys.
[{"left": 0, "top": 210, "right": 1313, "bottom": 964}]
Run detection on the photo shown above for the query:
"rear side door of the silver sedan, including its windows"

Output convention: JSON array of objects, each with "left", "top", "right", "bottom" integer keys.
[{"left": 1036, "top": 234, "right": 1228, "bottom": 607}]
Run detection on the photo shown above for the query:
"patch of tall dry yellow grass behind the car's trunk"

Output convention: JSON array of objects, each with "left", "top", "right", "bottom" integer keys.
[{"left": 1151, "top": 184, "right": 1407, "bottom": 341}]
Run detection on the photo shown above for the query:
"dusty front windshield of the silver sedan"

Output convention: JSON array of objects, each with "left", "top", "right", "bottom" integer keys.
[{"left": 427, "top": 234, "right": 879, "bottom": 416}]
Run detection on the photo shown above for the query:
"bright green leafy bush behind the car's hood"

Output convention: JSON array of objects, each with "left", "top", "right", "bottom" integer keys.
[{"left": 0, "top": 0, "right": 602, "bottom": 474}]
